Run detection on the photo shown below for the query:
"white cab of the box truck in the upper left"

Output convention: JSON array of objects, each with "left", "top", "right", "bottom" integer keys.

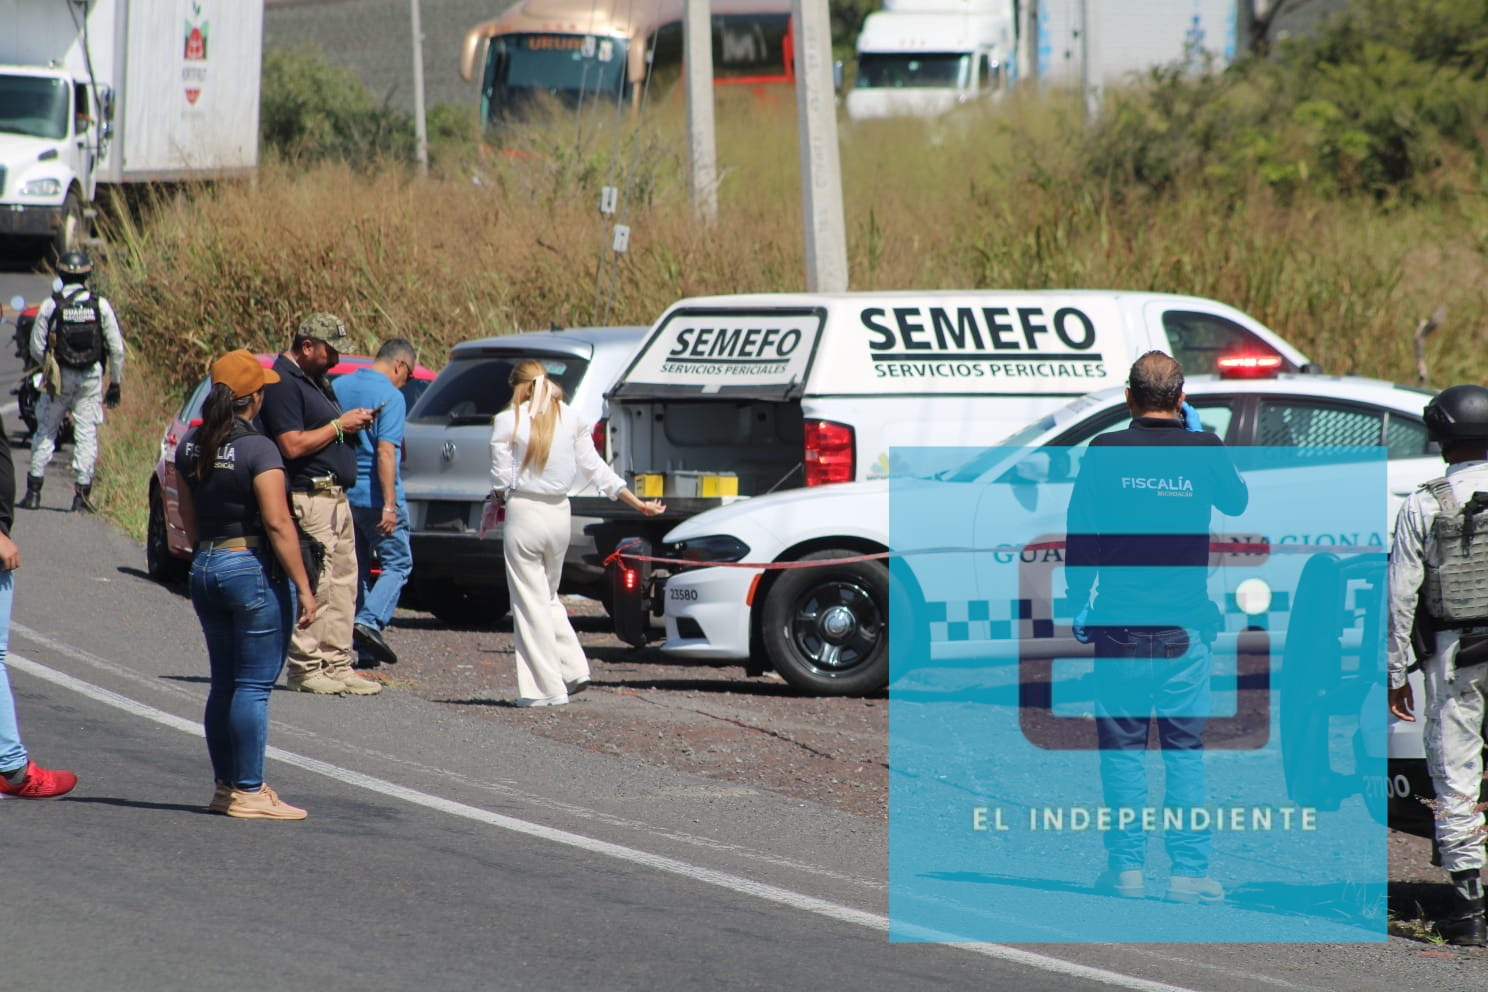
[{"left": 0, "top": 65, "right": 113, "bottom": 254}]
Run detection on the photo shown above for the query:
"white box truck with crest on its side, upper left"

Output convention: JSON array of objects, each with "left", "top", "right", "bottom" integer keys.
[{"left": 0, "top": 0, "right": 263, "bottom": 254}]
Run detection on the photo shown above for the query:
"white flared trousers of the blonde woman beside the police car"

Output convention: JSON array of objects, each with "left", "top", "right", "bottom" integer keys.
[{"left": 501, "top": 494, "right": 589, "bottom": 699}]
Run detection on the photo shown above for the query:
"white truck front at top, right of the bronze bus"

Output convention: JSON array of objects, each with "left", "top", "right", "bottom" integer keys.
[{"left": 847, "top": 0, "right": 1018, "bottom": 120}]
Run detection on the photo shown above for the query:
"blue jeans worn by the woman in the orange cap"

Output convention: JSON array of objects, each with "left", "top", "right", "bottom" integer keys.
[{"left": 190, "top": 549, "right": 295, "bottom": 791}]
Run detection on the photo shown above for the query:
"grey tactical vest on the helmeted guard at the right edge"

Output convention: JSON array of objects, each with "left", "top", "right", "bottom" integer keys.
[{"left": 1426, "top": 479, "right": 1488, "bottom": 628}]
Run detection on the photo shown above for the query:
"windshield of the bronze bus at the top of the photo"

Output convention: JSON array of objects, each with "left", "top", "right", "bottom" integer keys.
[{"left": 482, "top": 34, "right": 625, "bottom": 122}]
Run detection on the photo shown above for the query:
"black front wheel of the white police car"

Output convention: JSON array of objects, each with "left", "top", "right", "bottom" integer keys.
[{"left": 760, "top": 549, "right": 890, "bottom": 696}]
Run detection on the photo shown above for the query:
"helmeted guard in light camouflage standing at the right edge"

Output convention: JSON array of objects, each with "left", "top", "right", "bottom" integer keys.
[{"left": 1388, "top": 385, "right": 1488, "bottom": 947}]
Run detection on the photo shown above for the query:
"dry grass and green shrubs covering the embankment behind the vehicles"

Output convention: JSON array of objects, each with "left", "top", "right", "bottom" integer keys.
[{"left": 90, "top": 0, "right": 1488, "bottom": 531}]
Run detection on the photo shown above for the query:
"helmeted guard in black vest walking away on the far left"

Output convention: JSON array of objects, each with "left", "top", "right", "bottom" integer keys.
[{"left": 21, "top": 251, "right": 124, "bottom": 513}]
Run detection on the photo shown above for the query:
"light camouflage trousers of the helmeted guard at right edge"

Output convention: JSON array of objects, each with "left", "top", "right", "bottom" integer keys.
[{"left": 1423, "top": 651, "right": 1488, "bottom": 872}]
